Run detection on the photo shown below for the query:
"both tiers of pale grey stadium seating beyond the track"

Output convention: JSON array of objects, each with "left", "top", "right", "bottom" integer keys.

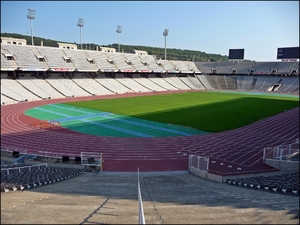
[{"left": 1, "top": 44, "right": 299, "bottom": 100}]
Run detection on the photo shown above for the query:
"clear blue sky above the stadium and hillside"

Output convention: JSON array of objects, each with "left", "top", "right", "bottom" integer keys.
[{"left": 1, "top": 1, "right": 299, "bottom": 61}]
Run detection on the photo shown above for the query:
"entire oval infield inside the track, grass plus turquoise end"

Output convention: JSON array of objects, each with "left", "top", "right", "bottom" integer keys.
[{"left": 24, "top": 91, "right": 299, "bottom": 138}]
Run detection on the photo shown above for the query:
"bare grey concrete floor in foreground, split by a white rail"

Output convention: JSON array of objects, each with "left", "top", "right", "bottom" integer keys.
[{"left": 1, "top": 172, "right": 299, "bottom": 224}]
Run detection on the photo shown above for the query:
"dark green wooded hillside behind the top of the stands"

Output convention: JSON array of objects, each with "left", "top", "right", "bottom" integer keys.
[{"left": 1, "top": 33, "right": 228, "bottom": 62}]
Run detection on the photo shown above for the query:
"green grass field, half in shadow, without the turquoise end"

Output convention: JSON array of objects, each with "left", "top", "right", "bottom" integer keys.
[{"left": 66, "top": 92, "right": 299, "bottom": 132}]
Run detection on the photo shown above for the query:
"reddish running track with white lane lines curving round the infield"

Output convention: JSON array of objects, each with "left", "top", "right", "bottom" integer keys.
[{"left": 1, "top": 92, "right": 299, "bottom": 175}]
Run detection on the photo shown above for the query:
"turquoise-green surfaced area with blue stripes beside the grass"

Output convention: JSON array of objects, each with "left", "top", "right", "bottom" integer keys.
[{"left": 24, "top": 104, "right": 208, "bottom": 138}]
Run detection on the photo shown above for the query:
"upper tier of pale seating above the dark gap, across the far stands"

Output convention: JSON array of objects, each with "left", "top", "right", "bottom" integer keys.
[{"left": 1, "top": 43, "right": 299, "bottom": 75}]
